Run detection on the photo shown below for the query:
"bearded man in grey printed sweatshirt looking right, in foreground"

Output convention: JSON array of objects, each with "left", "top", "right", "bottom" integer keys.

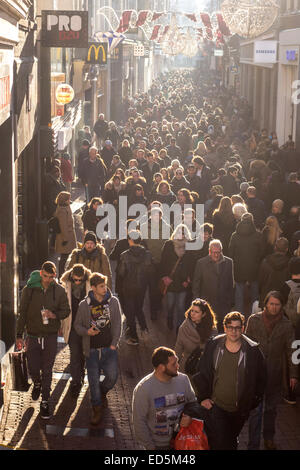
[{"left": 132, "top": 346, "right": 195, "bottom": 450}]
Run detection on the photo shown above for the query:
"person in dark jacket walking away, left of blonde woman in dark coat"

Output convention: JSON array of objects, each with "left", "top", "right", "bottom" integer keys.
[{"left": 117, "top": 230, "right": 153, "bottom": 346}]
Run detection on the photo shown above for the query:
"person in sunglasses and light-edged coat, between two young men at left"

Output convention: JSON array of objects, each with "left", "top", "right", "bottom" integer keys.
[{"left": 60, "top": 264, "right": 92, "bottom": 398}]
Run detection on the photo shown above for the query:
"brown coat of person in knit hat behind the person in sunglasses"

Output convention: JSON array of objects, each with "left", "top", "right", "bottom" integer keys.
[{"left": 66, "top": 243, "right": 112, "bottom": 289}]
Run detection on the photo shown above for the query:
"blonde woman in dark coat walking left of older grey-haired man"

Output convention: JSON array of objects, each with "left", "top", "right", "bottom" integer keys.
[{"left": 160, "top": 224, "right": 193, "bottom": 332}]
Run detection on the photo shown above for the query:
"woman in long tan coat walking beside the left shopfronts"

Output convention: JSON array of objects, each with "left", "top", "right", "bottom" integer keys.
[{"left": 54, "top": 191, "right": 77, "bottom": 277}]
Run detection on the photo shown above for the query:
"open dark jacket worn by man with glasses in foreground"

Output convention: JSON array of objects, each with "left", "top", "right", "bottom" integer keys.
[{"left": 184, "top": 335, "right": 266, "bottom": 417}]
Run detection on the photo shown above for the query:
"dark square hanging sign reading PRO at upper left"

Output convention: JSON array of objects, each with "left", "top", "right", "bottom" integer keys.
[{"left": 42, "top": 10, "right": 89, "bottom": 47}]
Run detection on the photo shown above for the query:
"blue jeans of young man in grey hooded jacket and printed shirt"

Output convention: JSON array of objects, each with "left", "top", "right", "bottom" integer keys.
[{"left": 86, "top": 348, "right": 118, "bottom": 406}]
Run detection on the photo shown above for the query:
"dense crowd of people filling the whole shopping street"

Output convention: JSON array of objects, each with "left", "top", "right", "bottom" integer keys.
[{"left": 17, "top": 70, "right": 300, "bottom": 449}]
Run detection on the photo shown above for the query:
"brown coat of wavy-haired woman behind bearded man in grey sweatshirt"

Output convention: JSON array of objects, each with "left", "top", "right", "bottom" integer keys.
[{"left": 174, "top": 318, "right": 217, "bottom": 373}]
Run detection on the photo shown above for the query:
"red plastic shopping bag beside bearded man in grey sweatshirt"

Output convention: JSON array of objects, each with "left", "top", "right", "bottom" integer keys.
[{"left": 174, "top": 418, "right": 209, "bottom": 450}]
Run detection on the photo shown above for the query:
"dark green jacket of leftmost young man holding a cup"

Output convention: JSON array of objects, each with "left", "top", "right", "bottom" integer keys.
[{"left": 16, "top": 271, "right": 70, "bottom": 338}]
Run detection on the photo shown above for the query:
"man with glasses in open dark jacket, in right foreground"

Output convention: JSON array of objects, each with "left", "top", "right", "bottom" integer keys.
[{"left": 184, "top": 312, "right": 266, "bottom": 450}]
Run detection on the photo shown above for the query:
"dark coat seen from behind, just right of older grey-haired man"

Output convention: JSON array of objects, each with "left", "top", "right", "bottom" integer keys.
[{"left": 228, "top": 219, "right": 264, "bottom": 282}]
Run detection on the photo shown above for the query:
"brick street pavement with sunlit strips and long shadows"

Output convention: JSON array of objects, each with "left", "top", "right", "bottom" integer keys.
[{"left": 0, "top": 185, "right": 300, "bottom": 451}]
